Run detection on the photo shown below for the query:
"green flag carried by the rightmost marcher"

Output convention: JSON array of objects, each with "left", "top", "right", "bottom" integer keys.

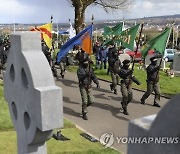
[{"left": 141, "top": 28, "right": 171, "bottom": 58}]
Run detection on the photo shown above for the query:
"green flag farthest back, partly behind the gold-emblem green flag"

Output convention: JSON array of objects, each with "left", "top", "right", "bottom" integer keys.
[{"left": 103, "top": 23, "right": 123, "bottom": 35}]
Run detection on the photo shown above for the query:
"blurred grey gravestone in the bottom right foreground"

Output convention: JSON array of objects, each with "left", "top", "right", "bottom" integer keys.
[{"left": 128, "top": 95, "right": 180, "bottom": 154}]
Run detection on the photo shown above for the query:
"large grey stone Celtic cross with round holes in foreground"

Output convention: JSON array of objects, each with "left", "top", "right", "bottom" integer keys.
[{"left": 4, "top": 32, "right": 63, "bottom": 154}]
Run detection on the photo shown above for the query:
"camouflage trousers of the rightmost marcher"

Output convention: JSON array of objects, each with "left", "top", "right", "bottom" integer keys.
[{"left": 141, "top": 81, "right": 160, "bottom": 103}]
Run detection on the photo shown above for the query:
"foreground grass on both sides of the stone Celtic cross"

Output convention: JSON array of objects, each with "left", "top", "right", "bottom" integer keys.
[{"left": 0, "top": 80, "right": 119, "bottom": 154}]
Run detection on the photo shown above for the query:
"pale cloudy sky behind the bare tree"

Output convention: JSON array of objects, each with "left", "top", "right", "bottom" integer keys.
[{"left": 0, "top": 0, "right": 180, "bottom": 24}]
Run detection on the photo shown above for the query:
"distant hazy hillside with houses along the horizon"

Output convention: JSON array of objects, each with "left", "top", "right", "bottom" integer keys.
[{"left": 0, "top": 14, "right": 180, "bottom": 31}]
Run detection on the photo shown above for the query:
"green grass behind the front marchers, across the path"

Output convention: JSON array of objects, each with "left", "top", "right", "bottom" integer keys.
[{"left": 68, "top": 64, "right": 180, "bottom": 96}]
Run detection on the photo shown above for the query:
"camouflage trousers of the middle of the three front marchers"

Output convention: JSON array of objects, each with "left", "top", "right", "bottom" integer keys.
[{"left": 121, "top": 83, "right": 133, "bottom": 109}]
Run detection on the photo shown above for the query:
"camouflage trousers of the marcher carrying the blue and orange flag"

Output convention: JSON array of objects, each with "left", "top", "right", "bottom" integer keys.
[{"left": 79, "top": 86, "right": 94, "bottom": 113}]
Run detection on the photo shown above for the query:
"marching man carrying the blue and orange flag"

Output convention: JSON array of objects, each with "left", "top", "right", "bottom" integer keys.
[{"left": 77, "top": 61, "right": 100, "bottom": 120}]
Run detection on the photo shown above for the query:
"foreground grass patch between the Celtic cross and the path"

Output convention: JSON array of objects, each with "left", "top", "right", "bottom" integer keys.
[{"left": 47, "top": 128, "right": 118, "bottom": 154}]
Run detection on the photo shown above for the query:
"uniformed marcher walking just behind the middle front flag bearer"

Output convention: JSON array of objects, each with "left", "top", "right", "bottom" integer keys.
[{"left": 109, "top": 52, "right": 121, "bottom": 94}]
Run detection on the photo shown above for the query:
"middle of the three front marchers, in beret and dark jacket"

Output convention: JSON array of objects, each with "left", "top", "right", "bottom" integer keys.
[{"left": 119, "top": 60, "right": 140, "bottom": 115}]
